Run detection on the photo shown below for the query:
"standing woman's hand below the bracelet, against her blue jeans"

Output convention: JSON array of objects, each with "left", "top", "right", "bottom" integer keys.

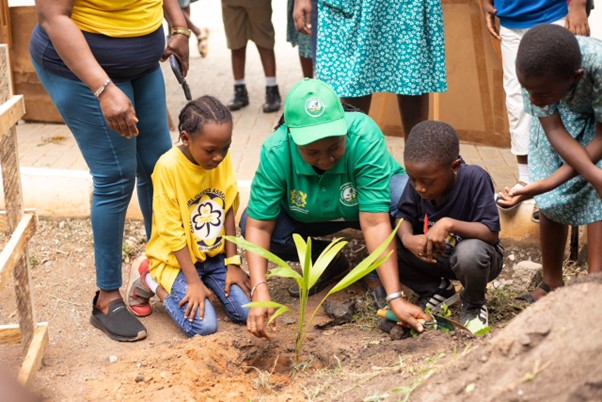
[{"left": 98, "top": 82, "right": 138, "bottom": 140}]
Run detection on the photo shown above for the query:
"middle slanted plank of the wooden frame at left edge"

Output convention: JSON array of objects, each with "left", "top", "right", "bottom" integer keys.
[{"left": 0, "top": 214, "right": 37, "bottom": 286}]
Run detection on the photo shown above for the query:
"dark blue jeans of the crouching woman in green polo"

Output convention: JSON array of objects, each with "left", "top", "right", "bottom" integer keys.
[{"left": 240, "top": 173, "right": 408, "bottom": 266}]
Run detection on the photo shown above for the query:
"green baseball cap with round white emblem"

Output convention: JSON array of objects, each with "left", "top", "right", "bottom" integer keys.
[{"left": 284, "top": 78, "right": 347, "bottom": 146}]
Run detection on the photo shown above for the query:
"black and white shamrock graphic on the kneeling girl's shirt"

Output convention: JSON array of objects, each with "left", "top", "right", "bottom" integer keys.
[{"left": 190, "top": 189, "right": 226, "bottom": 251}]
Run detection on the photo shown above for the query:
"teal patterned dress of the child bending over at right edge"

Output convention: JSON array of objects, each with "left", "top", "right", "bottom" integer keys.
[{"left": 523, "top": 36, "right": 602, "bottom": 225}]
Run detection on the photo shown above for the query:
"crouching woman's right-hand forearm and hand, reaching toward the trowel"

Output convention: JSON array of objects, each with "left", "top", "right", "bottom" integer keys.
[{"left": 360, "top": 212, "right": 430, "bottom": 332}]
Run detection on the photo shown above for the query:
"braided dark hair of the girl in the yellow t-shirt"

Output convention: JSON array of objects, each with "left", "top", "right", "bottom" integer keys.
[{"left": 178, "top": 95, "right": 232, "bottom": 139}]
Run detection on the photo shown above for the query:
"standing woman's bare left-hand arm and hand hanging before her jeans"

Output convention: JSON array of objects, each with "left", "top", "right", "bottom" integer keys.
[{"left": 36, "top": 0, "right": 138, "bottom": 138}]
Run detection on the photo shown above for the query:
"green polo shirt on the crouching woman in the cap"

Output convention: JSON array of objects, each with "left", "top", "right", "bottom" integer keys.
[{"left": 247, "top": 112, "right": 404, "bottom": 222}]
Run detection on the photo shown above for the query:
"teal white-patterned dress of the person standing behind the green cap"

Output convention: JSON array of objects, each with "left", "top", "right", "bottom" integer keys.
[{"left": 316, "top": 0, "right": 447, "bottom": 97}]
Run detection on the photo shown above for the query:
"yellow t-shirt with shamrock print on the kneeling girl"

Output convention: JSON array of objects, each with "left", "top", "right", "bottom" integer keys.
[{"left": 146, "top": 146, "right": 239, "bottom": 293}]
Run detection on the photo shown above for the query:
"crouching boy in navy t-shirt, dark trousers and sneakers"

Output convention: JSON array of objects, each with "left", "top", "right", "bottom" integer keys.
[{"left": 396, "top": 121, "right": 503, "bottom": 332}]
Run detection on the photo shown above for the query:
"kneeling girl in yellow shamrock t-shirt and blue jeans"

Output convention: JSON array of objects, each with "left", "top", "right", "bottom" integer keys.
[{"left": 127, "top": 96, "right": 250, "bottom": 337}]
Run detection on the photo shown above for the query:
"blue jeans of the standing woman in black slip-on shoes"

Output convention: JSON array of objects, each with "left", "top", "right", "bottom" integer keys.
[{"left": 34, "top": 62, "right": 172, "bottom": 290}]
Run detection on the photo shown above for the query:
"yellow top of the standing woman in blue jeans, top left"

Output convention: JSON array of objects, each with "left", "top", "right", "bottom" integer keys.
[{"left": 71, "top": 0, "right": 163, "bottom": 38}]
